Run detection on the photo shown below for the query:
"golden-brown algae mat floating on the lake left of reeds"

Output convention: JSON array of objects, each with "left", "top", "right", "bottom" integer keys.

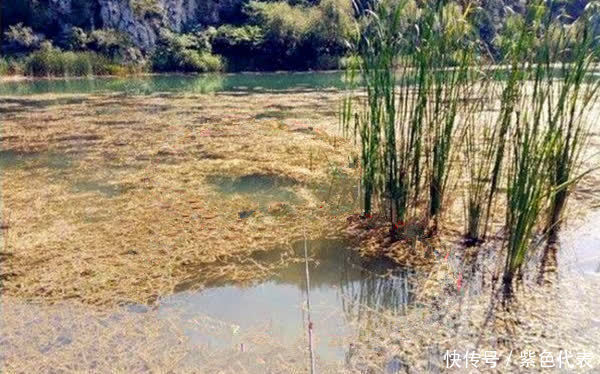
[{"left": 0, "top": 94, "right": 355, "bottom": 305}]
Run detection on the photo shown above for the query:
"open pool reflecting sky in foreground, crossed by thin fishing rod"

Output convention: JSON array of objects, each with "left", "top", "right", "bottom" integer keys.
[{"left": 159, "top": 240, "right": 415, "bottom": 362}]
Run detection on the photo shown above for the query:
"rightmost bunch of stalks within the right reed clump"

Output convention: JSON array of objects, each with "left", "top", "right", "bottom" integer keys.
[{"left": 541, "top": 5, "right": 600, "bottom": 272}]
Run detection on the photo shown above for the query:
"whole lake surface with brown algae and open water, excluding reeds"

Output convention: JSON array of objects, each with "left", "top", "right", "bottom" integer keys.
[{"left": 0, "top": 72, "right": 600, "bottom": 373}]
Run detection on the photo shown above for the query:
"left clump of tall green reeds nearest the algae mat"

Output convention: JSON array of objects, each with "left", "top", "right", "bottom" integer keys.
[{"left": 341, "top": 1, "right": 473, "bottom": 231}]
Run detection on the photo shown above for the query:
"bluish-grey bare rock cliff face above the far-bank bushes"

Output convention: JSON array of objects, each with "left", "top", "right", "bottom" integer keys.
[{"left": 0, "top": 0, "right": 600, "bottom": 51}]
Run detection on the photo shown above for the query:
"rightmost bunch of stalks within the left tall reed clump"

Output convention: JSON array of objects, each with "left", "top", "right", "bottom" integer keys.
[{"left": 424, "top": 2, "right": 476, "bottom": 226}]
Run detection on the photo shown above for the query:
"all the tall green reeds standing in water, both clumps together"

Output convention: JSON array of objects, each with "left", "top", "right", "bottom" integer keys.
[{"left": 342, "top": 1, "right": 598, "bottom": 299}]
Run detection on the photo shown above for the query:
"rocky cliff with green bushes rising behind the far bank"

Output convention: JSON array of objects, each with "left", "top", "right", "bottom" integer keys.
[{"left": 0, "top": 0, "right": 600, "bottom": 72}]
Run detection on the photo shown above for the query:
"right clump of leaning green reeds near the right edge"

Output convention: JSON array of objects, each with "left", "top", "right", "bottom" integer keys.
[{"left": 496, "top": 2, "right": 598, "bottom": 297}]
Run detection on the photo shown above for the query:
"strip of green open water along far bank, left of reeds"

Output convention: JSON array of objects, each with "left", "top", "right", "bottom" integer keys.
[{"left": 0, "top": 72, "right": 344, "bottom": 96}]
